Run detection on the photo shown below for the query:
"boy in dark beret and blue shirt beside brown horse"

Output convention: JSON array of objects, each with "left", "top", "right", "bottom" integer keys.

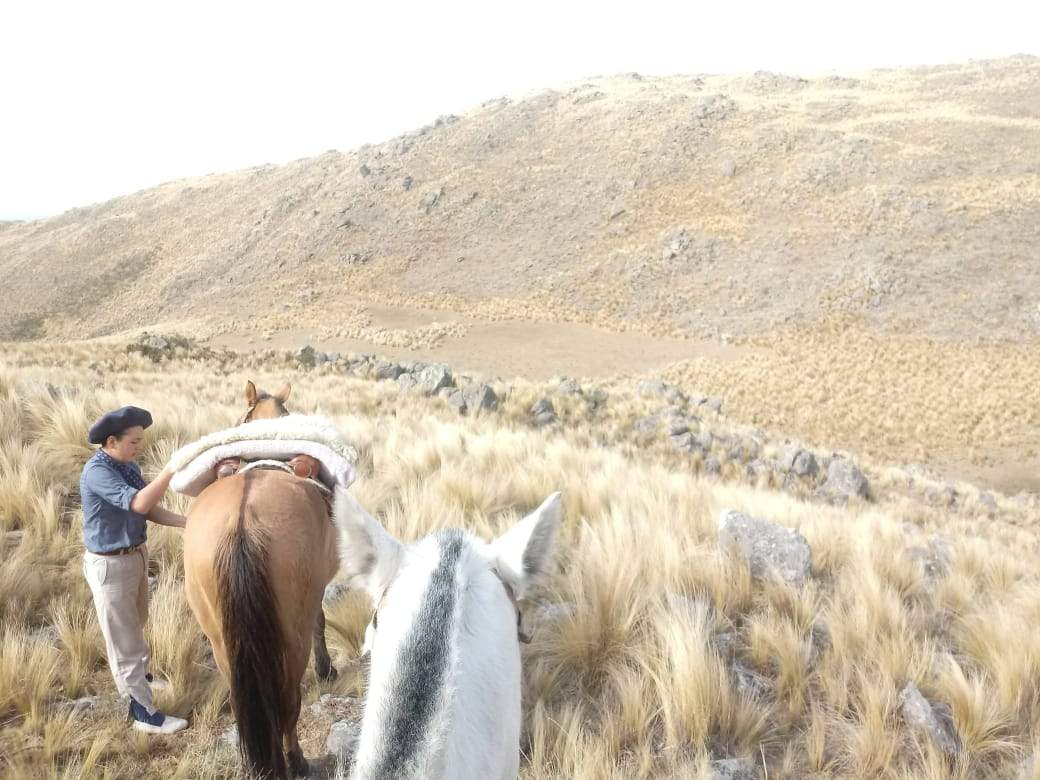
[{"left": 79, "top": 407, "right": 187, "bottom": 734}]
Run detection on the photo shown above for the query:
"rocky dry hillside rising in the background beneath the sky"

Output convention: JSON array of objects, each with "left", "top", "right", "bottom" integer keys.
[{"left": 0, "top": 57, "right": 1040, "bottom": 340}]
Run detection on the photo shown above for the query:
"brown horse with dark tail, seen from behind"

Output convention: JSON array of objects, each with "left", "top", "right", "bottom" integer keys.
[{"left": 184, "top": 382, "right": 339, "bottom": 778}]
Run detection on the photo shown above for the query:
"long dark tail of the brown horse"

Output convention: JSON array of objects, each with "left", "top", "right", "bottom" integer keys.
[{"left": 216, "top": 496, "right": 287, "bottom": 779}]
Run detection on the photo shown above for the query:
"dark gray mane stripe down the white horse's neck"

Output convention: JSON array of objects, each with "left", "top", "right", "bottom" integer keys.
[{"left": 366, "top": 529, "right": 471, "bottom": 778}]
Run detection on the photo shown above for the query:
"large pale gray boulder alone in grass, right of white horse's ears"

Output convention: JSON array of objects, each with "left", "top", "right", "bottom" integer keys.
[{"left": 719, "top": 510, "right": 812, "bottom": 586}]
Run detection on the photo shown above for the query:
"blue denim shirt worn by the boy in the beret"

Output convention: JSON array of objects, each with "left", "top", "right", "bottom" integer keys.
[{"left": 79, "top": 456, "right": 147, "bottom": 552}]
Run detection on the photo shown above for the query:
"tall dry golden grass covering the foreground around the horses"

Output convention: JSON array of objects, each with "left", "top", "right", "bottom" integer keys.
[{"left": 0, "top": 347, "right": 1040, "bottom": 779}]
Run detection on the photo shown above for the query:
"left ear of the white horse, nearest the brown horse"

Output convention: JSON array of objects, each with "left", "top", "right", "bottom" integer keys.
[{"left": 333, "top": 486, "right": 404, "bottom": 603}]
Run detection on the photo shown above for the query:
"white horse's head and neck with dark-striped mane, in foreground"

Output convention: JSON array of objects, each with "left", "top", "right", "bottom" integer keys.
[{"left": 334, "top": 489, "right": 561, "bottom": 780}]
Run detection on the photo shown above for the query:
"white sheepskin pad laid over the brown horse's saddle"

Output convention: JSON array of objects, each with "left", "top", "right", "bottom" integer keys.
[{"left": 166, "top": 414, "right": 358, "bottom": 496}]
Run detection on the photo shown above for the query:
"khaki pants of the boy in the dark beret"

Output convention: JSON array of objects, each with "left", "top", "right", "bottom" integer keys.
[{"left": 83, "top": 545, "right": 155, "bottom": 714}]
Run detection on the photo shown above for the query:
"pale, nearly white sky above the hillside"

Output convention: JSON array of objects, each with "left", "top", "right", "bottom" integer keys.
[{"left": 0, "top": 0, "right": 1040, "bottom": 219}]
